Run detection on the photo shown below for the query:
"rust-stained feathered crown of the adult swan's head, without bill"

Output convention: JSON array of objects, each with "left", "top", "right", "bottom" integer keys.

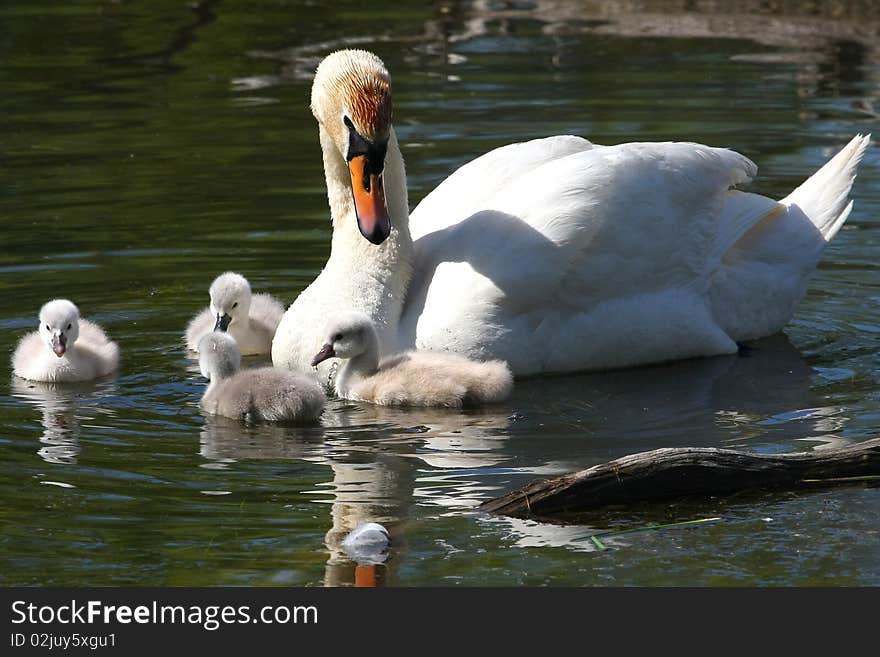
[{"left": 312, "top": 50, "right": 391, "bottom": 145}]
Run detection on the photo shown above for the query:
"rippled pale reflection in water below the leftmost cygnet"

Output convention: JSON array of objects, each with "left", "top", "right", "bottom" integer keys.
[{"left": 10, "top": 377, "right": 102, "bottom": 464}]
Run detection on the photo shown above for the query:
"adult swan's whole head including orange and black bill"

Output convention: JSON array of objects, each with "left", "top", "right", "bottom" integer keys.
[{"left": 312, "top": 50, "right": 391, "bottom": 244}]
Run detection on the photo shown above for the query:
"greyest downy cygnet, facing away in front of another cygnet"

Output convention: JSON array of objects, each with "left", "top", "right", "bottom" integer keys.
[{"left": 199, "top": 331, "right": 325, "bottom": 422}]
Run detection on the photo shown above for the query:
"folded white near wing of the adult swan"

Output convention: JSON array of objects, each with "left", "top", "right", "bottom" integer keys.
[{"left": 413, "top": 143, "right": 756, "bottom": 309}]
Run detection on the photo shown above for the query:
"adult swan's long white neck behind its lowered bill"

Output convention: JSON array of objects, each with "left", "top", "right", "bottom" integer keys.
[{"left": 320, "top": 126, "right": 413, "bottom": 356}]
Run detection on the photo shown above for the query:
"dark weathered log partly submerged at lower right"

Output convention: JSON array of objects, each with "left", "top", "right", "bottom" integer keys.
[{"left": 480, "top": 438, "right": 880, "bottom": 517}]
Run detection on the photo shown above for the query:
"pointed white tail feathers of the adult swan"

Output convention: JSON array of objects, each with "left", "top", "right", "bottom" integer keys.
[{"left": 781, "top": 135, "right": 871, "bottom": 246}]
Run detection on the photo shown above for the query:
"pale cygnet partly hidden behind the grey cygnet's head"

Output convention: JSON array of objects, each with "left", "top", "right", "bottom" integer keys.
[{"left": 186, "top": 272, "right": 284, "bottom": 356}]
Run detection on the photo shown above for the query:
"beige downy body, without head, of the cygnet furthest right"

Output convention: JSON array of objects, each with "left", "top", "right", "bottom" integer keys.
[{"left": 352, "top": 351, "right": 513, "bottom": 408}]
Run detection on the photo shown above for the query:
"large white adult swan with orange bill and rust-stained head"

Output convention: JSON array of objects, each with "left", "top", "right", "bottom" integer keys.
[{"left": 272, "top": 50, "right": 869, "bottom": 382}]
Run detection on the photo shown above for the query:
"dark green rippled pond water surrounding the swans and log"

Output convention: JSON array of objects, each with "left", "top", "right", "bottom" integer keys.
[{"left": 0, "top": 0, "right": 880, "bottom": 586}]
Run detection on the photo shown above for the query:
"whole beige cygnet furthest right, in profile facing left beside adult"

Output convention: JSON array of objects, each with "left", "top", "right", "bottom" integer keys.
[{"left": 312, "top": 313, "right": 513, "bottom": 408}]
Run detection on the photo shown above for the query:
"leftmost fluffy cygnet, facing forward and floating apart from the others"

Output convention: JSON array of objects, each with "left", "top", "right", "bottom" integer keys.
[{"left": 12, "top": 299, "right": 119, "bottom": 382}]
